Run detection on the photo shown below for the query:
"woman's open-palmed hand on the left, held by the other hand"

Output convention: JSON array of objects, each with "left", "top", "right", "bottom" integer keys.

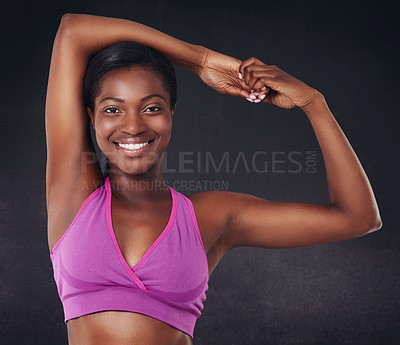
[{"left": 198, "top": 49, "right": 251, "bottom": 98}]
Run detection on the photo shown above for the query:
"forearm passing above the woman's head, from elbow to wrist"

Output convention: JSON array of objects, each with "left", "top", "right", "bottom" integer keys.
[{"left": 59, "top": 13, "right": 207, "bottom": 73}]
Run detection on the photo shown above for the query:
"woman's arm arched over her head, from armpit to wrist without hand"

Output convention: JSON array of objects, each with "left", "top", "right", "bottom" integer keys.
[{"left": 45, "top": 13, "right": 207, "bottom": 248}]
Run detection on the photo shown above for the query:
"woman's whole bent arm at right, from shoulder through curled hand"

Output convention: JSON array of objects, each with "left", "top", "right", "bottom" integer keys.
[{"left": 191, "top": 58, "right": 382, "bottom": 268}]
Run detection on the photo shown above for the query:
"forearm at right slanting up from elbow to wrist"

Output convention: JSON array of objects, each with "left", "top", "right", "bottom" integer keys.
[{"left": 303, "top": 93, "right": 381, "bottom": 230}]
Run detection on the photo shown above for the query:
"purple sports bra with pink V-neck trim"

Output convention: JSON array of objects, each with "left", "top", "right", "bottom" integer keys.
[{"left": 50, "top": 177, "right": 208, "bottom": 337}]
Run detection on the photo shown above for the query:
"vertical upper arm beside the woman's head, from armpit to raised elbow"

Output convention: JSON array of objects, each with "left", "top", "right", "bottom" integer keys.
[{"left": 45, "top": 16, "right": 102, "bottom": 242}]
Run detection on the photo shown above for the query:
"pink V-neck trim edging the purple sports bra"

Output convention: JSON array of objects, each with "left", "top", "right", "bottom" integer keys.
[{"left": 105, "top": 177, "right": 177, "bottom": 291}]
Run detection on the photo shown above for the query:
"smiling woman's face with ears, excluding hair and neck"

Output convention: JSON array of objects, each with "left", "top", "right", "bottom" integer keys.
[{"left": 87, "top": 66, "right": 175, "bottom": 175}]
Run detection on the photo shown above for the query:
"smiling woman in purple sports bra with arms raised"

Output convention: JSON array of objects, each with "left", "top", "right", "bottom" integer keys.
[{"left": 46, "top": 13, "right": 382, "bottom": 345}]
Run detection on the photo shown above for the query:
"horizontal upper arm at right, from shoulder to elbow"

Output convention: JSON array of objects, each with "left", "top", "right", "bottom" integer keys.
[{"left": 192, "top": 191, "right": 380, "bottom": 256}]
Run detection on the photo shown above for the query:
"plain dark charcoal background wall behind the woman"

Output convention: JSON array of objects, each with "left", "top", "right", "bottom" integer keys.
[{"left": 0, "top": 0, "right": 400, "bottom": 345}]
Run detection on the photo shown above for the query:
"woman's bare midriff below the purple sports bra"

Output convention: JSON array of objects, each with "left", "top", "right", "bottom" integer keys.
[{"left": 67, "top": 311, "right": 193, "bottom": 345}]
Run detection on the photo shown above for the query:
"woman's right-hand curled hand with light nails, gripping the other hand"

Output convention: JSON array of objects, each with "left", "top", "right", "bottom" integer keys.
[{"left": 238, "top": 57, "right": 319, "bottom": 109}]
